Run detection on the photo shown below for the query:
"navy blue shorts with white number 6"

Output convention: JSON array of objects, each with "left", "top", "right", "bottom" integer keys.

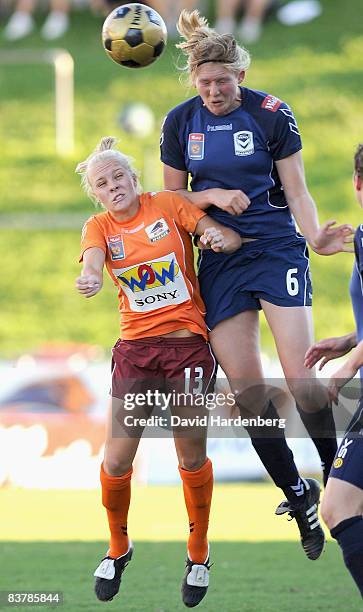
[{"left": 198, "top": 234, "right": 312, "bottom": 330}]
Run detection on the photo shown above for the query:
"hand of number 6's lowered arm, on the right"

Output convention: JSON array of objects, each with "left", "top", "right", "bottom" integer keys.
[{"left": 311, "top": 221, "right": 354, "bottom": 255}]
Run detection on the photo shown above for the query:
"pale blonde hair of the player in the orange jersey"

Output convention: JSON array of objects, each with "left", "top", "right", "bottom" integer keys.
[{"left": 75, "top": 136, "right": 142, "bottom": 204}]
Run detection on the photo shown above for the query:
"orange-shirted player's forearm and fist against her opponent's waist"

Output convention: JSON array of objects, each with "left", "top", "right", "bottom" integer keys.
[{"left": 195, "top": 215, "right": 242, "bottom": 253}]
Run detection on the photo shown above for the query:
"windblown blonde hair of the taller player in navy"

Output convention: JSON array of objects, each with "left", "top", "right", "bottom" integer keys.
[{"left": 176, "top": 9, "right": 251, "bottom": 84}]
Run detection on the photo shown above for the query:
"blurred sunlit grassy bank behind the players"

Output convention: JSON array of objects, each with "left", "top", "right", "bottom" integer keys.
[{"left": 0, "top": 0, "right": 363, "bottom": 356}]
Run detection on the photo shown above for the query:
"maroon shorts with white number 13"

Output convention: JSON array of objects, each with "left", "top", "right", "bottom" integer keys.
[{"left": 111, "top": 336, "right": 216, "bottom": 399}]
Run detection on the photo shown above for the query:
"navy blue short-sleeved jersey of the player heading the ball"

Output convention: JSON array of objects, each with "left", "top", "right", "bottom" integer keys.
[{"left": 161, "top": 87, "right": 302, "bottom": 238}]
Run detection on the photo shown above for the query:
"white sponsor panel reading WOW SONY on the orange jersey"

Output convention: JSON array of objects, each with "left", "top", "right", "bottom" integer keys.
[{"left": 112, "top": 253, "right": 190, "bottom": 312}]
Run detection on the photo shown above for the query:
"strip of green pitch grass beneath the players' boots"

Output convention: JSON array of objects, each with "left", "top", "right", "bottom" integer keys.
[{"left": 0, "top": 541, "right": 362, "bottom": 612}]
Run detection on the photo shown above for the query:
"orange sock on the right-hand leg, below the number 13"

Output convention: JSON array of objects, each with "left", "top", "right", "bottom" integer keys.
[{"left": 179, "top": 459, "right": 213, "bottom": 563}]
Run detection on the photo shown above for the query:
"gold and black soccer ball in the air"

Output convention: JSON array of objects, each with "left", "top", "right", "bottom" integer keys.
[{"left": 102, "top": 3, "right": 167, "bottom": 68}]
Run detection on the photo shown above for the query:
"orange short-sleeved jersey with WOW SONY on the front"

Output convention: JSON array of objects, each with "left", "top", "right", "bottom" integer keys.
[{"left": 80, "top": 191, "right": 207, "bottom": 340}]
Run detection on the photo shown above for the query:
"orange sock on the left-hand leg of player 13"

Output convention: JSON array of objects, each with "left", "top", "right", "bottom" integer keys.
[{"left": 101, "top": 464, "right": 132, "bottom": 559}]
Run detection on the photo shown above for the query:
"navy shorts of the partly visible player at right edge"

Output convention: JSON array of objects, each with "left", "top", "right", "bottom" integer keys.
[{"left": 329, "top": 399, "right": 363, "bottom": 489}]
